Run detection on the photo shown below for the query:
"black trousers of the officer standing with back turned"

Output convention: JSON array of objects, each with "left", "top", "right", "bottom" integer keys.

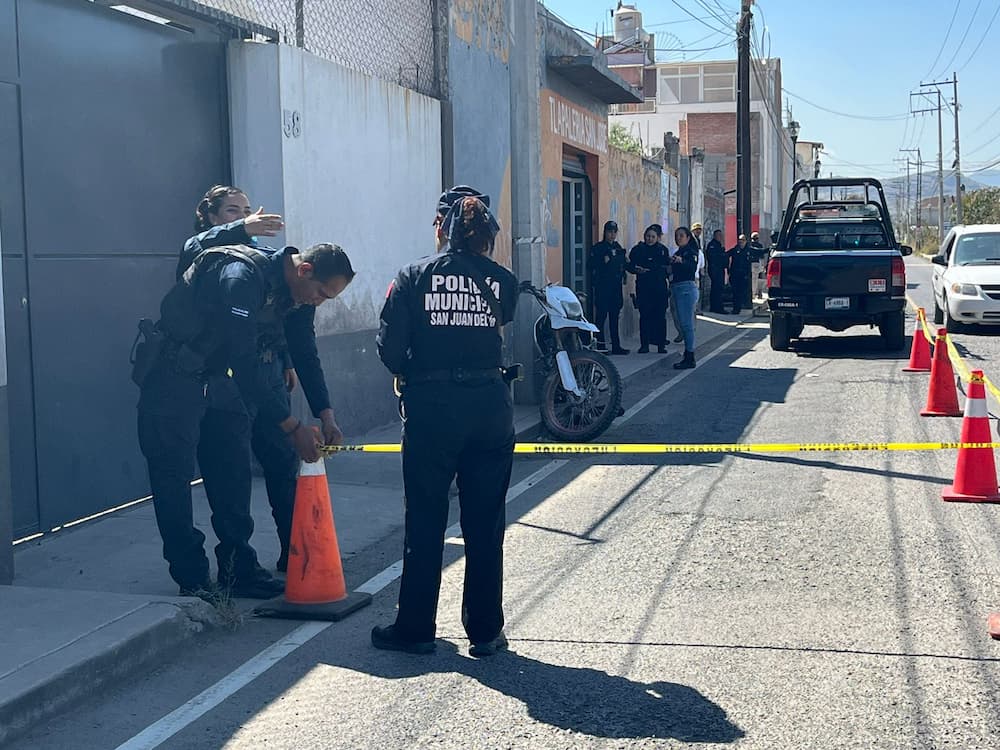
[{"left": 396, "top": 380, "right": 514, "bottom": 643}]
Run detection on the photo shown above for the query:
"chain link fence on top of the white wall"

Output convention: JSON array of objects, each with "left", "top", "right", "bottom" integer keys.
[{"left": 188, "top": 0, "right": 443, "bottom": 96}]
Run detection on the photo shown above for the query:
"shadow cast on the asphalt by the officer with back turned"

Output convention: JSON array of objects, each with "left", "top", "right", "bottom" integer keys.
[{"left": 328, "top": 640, "right": 745, "bottom": 744}]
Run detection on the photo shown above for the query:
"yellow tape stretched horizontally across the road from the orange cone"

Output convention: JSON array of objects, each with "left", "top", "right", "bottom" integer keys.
[{"left": 321, "top": 442, "right": 1000, "bottom": 456}]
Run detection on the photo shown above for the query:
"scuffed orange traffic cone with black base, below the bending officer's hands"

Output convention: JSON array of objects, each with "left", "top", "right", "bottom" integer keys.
[{"left": 254, "top": 460, "right": 372, "bottom": 620}]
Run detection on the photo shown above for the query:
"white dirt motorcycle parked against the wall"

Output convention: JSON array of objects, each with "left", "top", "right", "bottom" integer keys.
[{"left": 521, "top": 282, "right": 624, "bottom": 442}]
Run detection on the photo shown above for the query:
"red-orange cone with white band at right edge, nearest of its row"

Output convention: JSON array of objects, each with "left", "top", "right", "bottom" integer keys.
[{"left": 941, "top": 370, "right": 1000, "bottom": 503}]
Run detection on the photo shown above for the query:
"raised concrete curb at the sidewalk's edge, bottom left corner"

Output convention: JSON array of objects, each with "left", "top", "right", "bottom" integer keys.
[{"left": 0, "top": 600, "right": 219, "bottom": 746}]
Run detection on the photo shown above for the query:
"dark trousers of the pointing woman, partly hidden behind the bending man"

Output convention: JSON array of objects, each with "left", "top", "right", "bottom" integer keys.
[{"left": 250, "top": 358, "right": 299, "bottom": 556}]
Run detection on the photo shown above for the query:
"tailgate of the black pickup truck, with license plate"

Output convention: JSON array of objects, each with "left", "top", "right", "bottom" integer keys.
[{"left": 780, "top": 250, "right": 892, "bottom": 296}]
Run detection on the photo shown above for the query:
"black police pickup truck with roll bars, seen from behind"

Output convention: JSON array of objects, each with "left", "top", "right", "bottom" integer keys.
[{"left": 767, "top": 177, "right": 913, "bottom": 351}]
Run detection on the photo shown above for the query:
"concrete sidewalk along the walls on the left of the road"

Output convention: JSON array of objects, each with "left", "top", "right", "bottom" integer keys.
[{"left": 0, "top": 315, "right": 749, "bottom": 744}]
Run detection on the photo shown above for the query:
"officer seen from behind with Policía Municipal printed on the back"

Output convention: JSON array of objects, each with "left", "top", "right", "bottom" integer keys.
[{"left": 371, "top": 186, "right": 518, "bottom": 656}]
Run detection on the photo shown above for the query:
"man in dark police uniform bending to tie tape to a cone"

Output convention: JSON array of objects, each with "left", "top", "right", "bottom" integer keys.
[{"left": 138, "top": 244, "right": 354, "bottom": 601}]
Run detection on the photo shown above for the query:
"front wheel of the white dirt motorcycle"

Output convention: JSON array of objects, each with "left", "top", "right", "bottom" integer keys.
[{"left": 540, "top": 349, "right": 622, "bottom": 443}]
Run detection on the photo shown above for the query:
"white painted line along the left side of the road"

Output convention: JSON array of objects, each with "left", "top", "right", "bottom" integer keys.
[{"left": 117, "top": 329, "right": 750, "bottom": 750}]
